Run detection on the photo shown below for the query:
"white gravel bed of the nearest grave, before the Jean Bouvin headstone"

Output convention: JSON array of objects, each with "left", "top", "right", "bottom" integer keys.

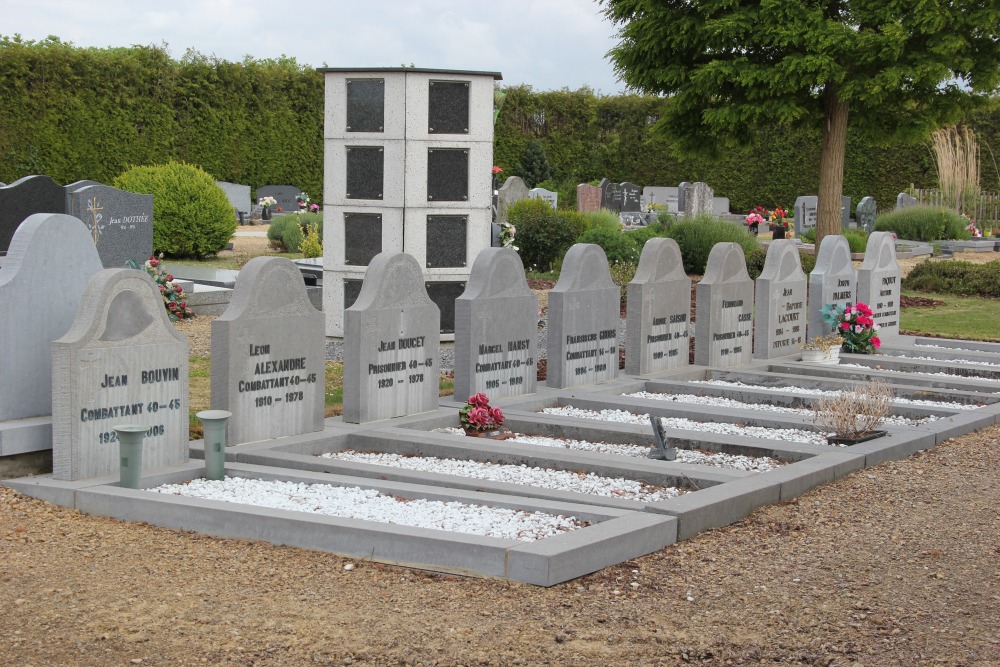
[{"left": 149, "top": 477, "right": 588, "bottom": 542}]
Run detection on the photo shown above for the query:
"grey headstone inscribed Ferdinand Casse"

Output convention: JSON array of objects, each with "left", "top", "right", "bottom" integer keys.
[{"left": 694, "top": 243, "right": 754, "bottom": 368}]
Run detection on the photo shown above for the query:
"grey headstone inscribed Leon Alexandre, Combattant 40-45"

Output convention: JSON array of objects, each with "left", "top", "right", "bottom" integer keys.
[{"left": 211, "top": 257, "right": 326, "bottom": 445}]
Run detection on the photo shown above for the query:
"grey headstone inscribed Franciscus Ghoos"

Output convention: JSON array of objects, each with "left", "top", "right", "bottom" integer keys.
[{"left": 546, "top": 243, "right": 621, "bottom": 388}]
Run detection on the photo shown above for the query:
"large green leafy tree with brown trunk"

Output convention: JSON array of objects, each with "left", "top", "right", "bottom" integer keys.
[{"left": 598, "top": 0, "right": 1000, "bottom": 242}]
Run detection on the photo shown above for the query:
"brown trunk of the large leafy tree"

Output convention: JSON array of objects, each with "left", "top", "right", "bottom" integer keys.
[{"left": 816, "top": 84, "right": 848, "bottom": 248}]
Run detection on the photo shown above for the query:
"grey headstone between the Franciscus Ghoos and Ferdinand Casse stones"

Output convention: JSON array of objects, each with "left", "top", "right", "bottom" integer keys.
[{"left": 625, "top": 237, "right": 691, "bottom": 375}]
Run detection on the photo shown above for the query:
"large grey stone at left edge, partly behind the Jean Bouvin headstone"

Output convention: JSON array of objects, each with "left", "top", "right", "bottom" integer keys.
[{"left": 0, "top": 213, "right": 101, "bottom": 456}]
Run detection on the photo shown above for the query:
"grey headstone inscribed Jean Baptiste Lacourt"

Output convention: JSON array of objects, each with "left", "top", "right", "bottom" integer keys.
[{"left": 753, "top": 239, "right": 806, "bottom": 359}]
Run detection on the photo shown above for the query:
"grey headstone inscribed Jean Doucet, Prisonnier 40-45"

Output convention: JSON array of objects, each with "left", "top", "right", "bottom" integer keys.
[{"left": 344, "top": 252, "right": 440, "bottom": 424}]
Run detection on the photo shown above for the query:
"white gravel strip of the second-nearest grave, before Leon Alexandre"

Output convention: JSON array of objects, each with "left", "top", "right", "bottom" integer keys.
[{"left": 320, "top": 450, "right": 682, "bottom": 503}]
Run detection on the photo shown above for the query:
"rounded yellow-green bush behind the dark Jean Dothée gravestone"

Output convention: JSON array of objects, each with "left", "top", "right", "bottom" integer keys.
[{"left": 114, "top": 162, "right": 237, "bottom": 259}]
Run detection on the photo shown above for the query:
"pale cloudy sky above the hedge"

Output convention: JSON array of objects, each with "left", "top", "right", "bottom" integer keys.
[{"left": 0, "top": 0, "right": 624, "bottom": 95}]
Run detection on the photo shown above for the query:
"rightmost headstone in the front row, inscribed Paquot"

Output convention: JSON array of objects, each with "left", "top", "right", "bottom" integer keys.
[{"left": 858, "top": 232, "right": 902, "bottom": 338}]
